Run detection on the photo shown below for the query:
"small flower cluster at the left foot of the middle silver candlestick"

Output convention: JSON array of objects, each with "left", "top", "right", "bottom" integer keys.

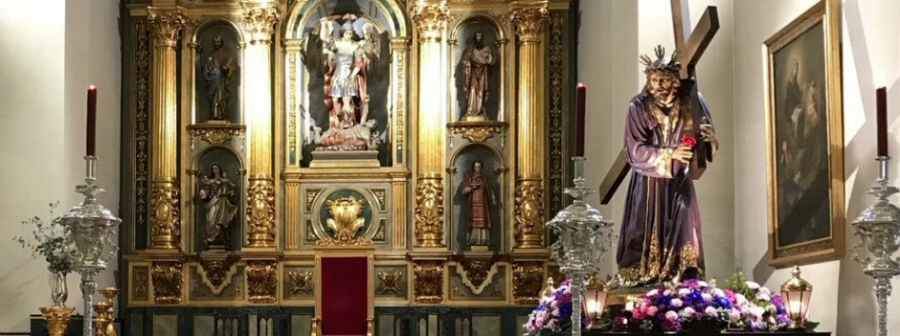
[{"left": 524, "top": 280, "right": 589, "bottom": 336}]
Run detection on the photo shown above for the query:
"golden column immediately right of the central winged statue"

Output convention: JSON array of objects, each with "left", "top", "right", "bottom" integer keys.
[{"left": 410, "top": 0, "right": 450, "bottom": 248}]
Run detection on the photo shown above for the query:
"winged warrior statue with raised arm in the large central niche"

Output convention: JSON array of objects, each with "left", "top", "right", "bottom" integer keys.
[{"left": 314, "top": 14, "right": 381, "bottom": 150}]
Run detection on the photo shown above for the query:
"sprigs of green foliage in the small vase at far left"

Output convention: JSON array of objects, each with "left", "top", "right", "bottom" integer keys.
[{"left": 13, "top": 201, "right": 75, "bottom": 274}]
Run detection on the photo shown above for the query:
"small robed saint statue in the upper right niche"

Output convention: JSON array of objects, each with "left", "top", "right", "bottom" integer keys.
[{"left": 462, "top": 31, "right": 497, "bottom": 120}]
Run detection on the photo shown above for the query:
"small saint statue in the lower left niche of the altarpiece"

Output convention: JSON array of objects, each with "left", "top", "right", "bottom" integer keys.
[{"left": 197, "top": 163, "right": 238, "bottom": 248}]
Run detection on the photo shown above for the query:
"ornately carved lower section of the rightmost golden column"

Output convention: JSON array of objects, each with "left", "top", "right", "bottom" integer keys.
[{"left": 515, "top": 178, "right": 544, "bottom": 249}]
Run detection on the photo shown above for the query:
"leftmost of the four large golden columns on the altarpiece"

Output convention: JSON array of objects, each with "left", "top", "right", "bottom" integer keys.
[{"left": 147, "top": 7, "right": 186, "bottom": 250}]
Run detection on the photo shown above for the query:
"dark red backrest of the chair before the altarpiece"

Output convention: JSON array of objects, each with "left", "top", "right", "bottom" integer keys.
[{"left": 318, "top": 256, "right": 373, "bottom": 335}]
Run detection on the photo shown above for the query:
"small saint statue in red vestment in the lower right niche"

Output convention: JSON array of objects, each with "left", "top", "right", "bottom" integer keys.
[{"left": 461, "top": 160, "right": 497, "bottom": 247}]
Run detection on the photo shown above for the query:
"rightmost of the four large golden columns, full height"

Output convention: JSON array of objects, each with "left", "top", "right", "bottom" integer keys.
[{"left": 510, "top": 0, "right": 549, "bottom": 249}]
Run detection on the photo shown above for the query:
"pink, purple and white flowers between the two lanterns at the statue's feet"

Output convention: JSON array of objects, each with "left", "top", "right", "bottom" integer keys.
[{"left": 612, "top": 273, "right": 817, "bottom": 331}]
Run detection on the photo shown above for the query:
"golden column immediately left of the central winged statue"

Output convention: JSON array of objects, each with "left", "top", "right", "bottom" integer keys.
[{"left": 241, "top": 2, "right": 278, "bottom": 248}]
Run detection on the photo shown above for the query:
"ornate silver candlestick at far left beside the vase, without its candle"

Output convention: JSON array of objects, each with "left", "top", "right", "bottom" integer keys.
[{"left": 61, "top": 155, "right": 122, "bottom": 335}]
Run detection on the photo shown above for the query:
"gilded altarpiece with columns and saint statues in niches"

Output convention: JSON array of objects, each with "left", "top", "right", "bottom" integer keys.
[{"left": 120, "top": 0, "right": 577, "bottom": 335}]
